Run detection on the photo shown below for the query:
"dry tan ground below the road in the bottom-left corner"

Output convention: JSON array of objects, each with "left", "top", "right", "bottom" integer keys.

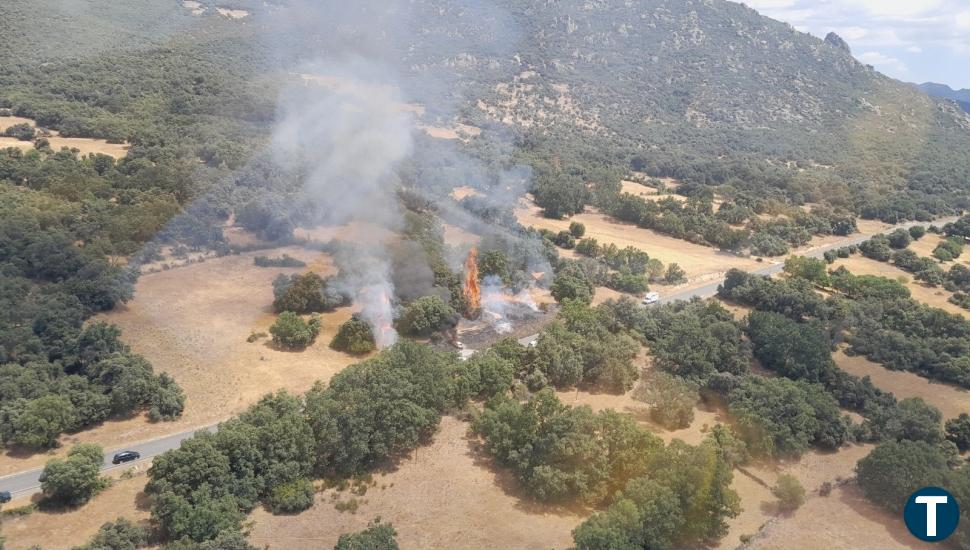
[{"left": 2, "top": 466, "right": 150, "bottom": 550}]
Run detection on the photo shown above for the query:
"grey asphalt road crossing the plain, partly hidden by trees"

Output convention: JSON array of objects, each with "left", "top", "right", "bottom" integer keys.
[{"left": 0, "top": 217, "right": 958, "bottom": 498}]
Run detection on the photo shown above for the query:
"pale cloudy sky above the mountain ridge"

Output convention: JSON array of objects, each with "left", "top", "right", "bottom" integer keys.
[{"left": 744, "top": 0, "right": 970, "bottom": 89}]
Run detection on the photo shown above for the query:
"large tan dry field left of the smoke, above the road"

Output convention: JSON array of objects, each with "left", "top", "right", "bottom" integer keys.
[{"left": 0, "top": 247, "right": 359, "bottom": 475}]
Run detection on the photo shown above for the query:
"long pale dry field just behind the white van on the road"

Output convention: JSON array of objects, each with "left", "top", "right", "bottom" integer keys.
[{"left": 515, "top": 199, "right": 759, "bottom": 283}]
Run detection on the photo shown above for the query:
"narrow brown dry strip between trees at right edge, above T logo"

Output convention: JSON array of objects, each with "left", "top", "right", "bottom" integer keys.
[{"left": 832, "top": 351, "right": 970, "bottom": 418}]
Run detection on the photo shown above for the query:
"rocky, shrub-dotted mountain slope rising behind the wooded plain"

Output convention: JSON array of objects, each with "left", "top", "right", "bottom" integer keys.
[{"left": 0, "top": 0, "right": 970, "bottom": 221}]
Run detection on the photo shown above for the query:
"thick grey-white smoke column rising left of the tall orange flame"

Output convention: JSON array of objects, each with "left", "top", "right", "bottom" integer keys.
[{"left": 274, "top": 61, "right": 413, "bottom": 347}]
